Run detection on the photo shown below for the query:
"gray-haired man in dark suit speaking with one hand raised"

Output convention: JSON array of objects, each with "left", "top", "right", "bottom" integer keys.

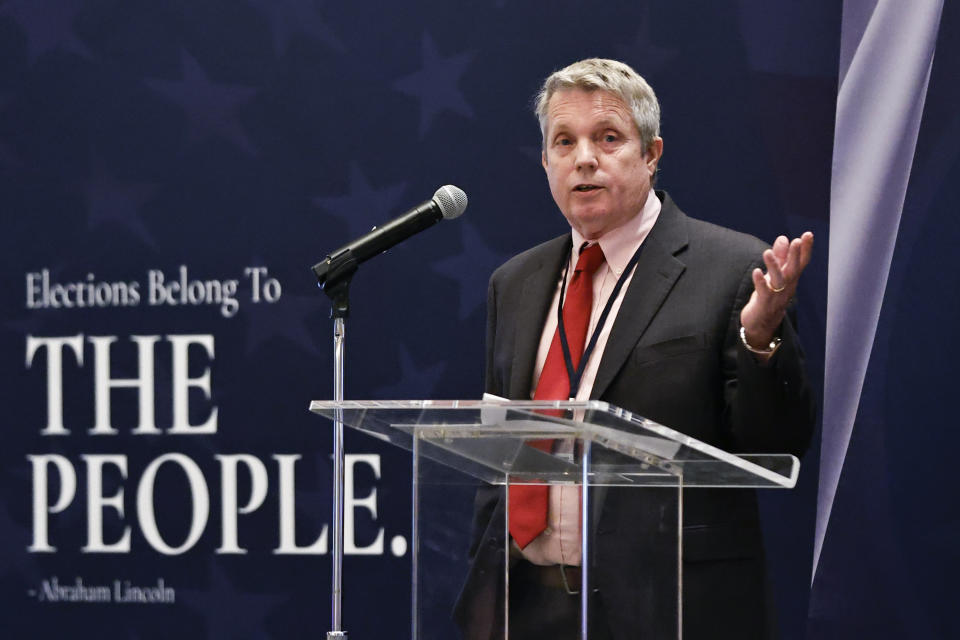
[{"left": 458, "top": 59, "right": 814, "bottom": 640}]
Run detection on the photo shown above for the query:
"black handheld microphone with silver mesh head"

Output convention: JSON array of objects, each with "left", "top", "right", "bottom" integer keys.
[{"left": 313, "top": 184, "right": 467, "bottom": 288}]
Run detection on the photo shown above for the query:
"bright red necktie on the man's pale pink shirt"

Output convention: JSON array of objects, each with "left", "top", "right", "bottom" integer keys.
[{"left": 510, "top": 244, "right": 604, "bottom": 549}]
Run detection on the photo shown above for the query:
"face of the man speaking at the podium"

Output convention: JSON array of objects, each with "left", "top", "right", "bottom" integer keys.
[{"left": 543, "top": 89, "right": 663, "bottom": 240}]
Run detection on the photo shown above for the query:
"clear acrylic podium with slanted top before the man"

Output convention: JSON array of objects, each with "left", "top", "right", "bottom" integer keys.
[{"left": 310, "top": 400, "right": 800, "bottom": 640}]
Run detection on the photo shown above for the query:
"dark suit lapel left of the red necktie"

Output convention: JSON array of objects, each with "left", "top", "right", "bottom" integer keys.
[{"left": 508, "top": 234, "right": 571, "bottom": 400}]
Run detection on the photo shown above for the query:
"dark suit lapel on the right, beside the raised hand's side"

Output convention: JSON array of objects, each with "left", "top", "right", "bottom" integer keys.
[{"left": 590, "top": 193, "right": 687, "bottom": 398}]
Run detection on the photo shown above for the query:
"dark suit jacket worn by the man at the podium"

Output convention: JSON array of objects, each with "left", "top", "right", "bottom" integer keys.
[{"left": 458, "top": 192, "right": 814, "bottom": 640}]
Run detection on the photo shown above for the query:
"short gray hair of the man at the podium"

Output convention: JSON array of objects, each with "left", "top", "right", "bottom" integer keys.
[{"left": 534, "top": 58, "right": 660, "bottom": 151}]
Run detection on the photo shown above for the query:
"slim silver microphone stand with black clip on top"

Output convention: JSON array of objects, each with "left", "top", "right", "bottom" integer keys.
[{"left": 313, "top": 249, "right": 358, "bottom": 640}]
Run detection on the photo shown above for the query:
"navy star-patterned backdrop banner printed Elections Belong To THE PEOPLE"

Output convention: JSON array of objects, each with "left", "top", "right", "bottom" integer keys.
[{"left": 0, "top": 0, "right": 841, "bottom": 639}]
